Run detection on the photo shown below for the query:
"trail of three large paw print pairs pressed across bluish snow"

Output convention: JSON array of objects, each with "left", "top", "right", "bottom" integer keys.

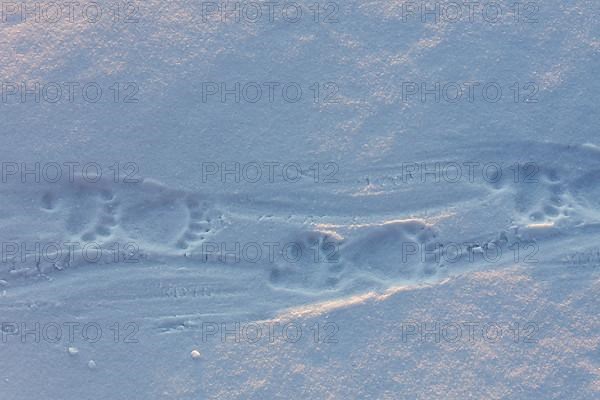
[{"left": 7, "top": 145, "right": 600, "bottom": 293}]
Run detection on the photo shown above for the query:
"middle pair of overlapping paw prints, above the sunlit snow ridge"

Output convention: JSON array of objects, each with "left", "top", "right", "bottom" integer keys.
[{"left": 270, "top": 220, "right": 446, "bottom": 292}]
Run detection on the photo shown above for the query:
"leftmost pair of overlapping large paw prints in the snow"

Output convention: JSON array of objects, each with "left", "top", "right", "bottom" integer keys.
[{"left": 61, "top": 180, "right": 225, "bottom": 249}]
